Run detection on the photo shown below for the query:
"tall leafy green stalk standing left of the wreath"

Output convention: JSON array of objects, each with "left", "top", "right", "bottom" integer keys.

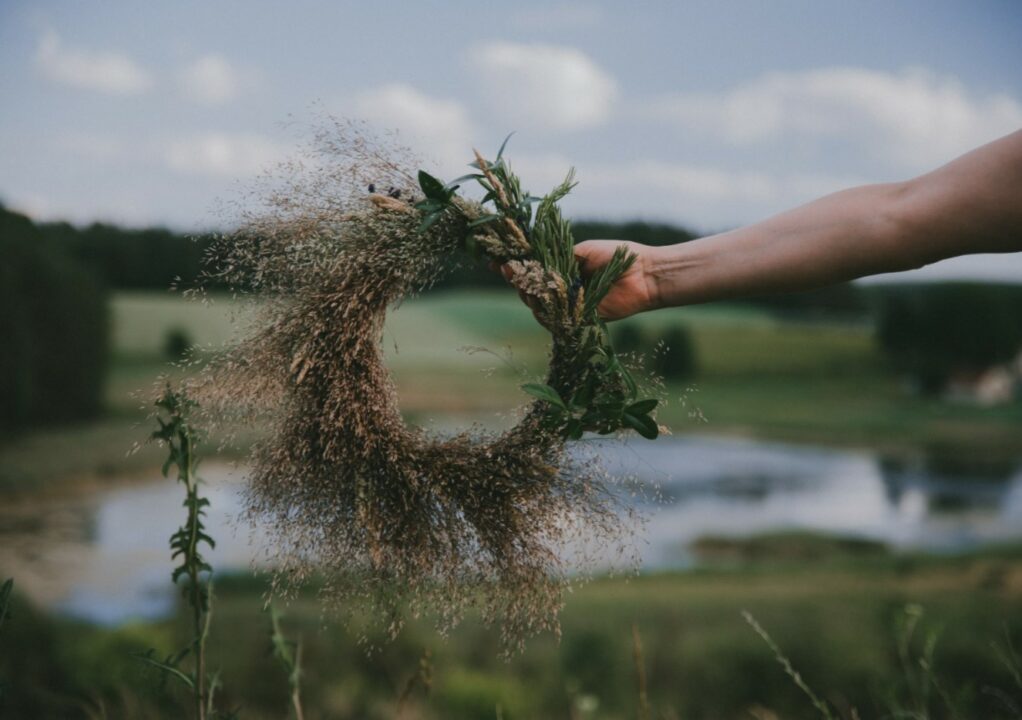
[{"left": 139, "top": 385, "right": 234, "bottom": 720}]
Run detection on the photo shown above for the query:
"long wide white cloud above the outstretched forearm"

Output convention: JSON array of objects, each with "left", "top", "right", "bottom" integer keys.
[{"left": 646, "top": 67, "right": 1022, "bottom": 171}]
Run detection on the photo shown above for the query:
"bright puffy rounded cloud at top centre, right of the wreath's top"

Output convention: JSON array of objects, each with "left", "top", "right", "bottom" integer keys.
[{"left": 468, "top": 42, "right": 617, "bottom": 130}]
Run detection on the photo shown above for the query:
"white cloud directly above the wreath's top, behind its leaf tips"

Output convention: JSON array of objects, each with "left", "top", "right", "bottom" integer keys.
[{"left": 354, "top": 84, "right": 473, "bottom": 175}]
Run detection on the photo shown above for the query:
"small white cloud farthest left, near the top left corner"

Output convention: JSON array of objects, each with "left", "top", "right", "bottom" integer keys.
[{"left": 36, "top": 31, "right": 152, "bottom": 95}]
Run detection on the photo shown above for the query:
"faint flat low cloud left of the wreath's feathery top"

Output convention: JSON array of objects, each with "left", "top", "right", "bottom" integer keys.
[{"left": 165, "top": 133, "right": 286, "bottom": 178}]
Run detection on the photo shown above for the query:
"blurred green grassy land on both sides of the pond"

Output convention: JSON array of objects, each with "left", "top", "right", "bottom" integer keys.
[{"left": 0, "top": 291, "right": 1022, "bottom": 720}]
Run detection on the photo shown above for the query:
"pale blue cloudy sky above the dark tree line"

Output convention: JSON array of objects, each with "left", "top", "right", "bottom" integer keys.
[{"left": 0, "top": 0, "right": 1022, "bottom": 281}]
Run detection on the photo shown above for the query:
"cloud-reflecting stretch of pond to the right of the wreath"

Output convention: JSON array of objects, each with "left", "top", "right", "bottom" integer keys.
[{"left": 588, "top": 437, "right": 1022, "bottom": 567}]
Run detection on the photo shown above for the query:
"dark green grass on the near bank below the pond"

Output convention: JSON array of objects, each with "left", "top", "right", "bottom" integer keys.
[{"left": 0, "top": 538, "right": 1022, "bottom": 720}]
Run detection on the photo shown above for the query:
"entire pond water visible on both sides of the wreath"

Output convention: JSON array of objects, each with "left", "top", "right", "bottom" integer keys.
[{"left": 0, "top": 437, "right": 1022, "bottom": 623}]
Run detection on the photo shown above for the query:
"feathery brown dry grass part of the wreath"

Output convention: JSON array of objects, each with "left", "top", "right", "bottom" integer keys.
[{"left": 186, "top": 123, "right": 629, "bottom": 651}]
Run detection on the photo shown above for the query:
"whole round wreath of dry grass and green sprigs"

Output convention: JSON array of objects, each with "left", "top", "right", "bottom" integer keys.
[{"left": 200, "top": 124, "right": 658, "bottom": 650}]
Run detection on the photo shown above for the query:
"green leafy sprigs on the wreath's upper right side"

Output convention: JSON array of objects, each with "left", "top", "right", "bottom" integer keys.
[{"left": 415, "top": 135, "right": 659, "bottom": 439}]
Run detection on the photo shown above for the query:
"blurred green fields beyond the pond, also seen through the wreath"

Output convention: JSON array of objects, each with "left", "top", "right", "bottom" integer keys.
[{"left": 0, "top": 291, "right": 1022, "bottom": 490}]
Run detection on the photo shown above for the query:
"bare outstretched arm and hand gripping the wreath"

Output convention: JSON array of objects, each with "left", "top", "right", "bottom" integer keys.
[{"left": 575, "top": 130, "right": 1022, "bottom": 320}]
